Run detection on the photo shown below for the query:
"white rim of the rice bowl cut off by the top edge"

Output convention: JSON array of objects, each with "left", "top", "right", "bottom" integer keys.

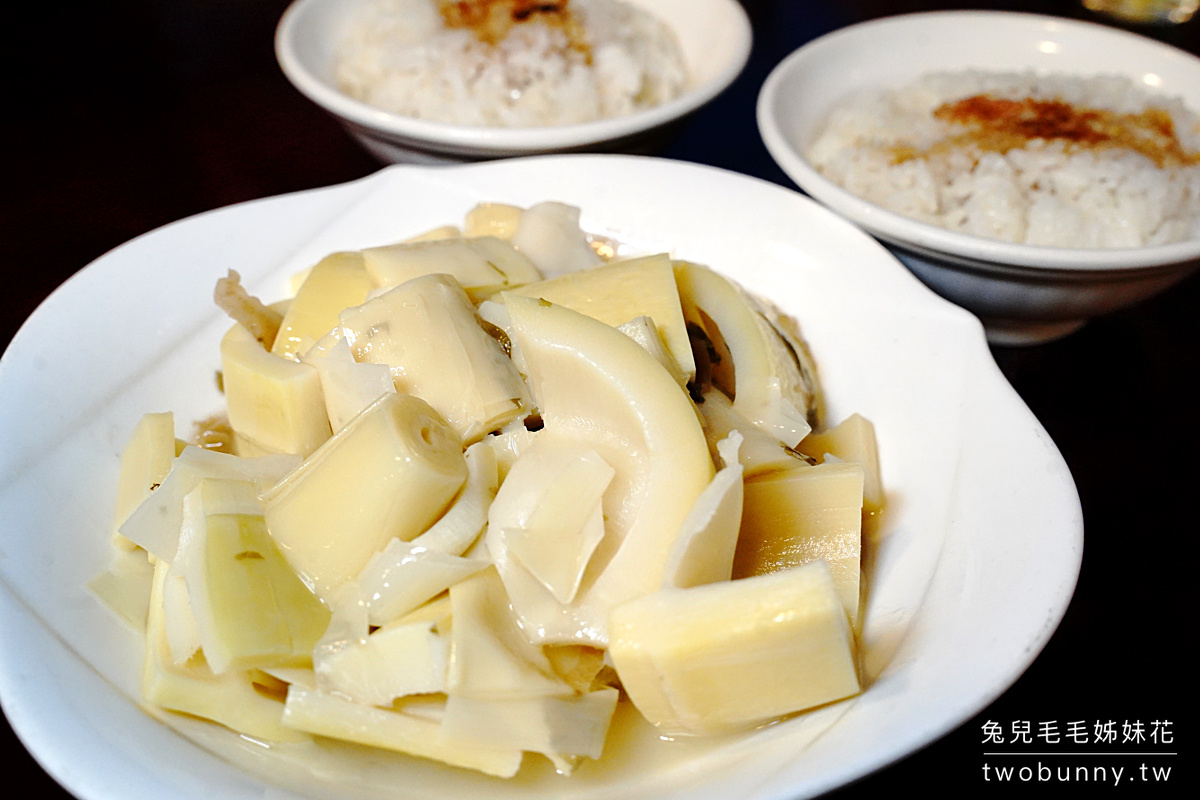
[{"left": 275, "top": 0, "right": 754, "bottom": 154}]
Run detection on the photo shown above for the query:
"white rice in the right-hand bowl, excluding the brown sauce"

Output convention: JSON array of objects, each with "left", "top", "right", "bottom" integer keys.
[{"left": 808, "top": 72, "right": 1200, "bottom": 248}]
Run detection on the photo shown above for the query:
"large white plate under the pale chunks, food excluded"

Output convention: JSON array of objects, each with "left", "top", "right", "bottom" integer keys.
[{"left": 0, "top": 156, "right": 1082, "bottom": 800}]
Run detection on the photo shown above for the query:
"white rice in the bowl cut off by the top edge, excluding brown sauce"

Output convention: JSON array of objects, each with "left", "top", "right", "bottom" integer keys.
[{"left": 336, "top": 0, "right": 686, "bottom": 127}]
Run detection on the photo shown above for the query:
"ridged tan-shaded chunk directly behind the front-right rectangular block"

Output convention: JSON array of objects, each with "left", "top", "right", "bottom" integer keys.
[{"left": 733, "top": 462, "right": 863, "bottom": 625}]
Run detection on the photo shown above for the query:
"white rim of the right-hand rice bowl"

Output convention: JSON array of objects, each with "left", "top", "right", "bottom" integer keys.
[{"left": 756, "top": 10, "right": 1200, "bottom": 273}]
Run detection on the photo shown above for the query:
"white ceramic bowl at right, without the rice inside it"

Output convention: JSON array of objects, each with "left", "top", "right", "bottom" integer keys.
[{"left": 758, "top": 11, "right": 1200, "bottom": 344}]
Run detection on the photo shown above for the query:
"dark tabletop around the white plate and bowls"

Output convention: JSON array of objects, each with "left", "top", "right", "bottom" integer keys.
[{"left": 0, "top": 0, "right": 1200, "bottom": 800}]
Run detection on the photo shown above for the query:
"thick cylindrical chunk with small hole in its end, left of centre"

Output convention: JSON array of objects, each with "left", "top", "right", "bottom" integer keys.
[{"left": 263, "top": 393, "right": 467, "bottom": 600}]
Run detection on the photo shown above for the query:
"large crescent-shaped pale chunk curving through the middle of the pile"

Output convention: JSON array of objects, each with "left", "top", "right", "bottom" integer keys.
[{"left": 486, "top": 293, "right": 715, "bottom": 646}]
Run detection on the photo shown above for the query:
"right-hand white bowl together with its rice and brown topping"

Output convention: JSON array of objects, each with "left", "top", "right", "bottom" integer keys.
[{"left": 757, "top": 11, "right": 1200, "bottom": 344}]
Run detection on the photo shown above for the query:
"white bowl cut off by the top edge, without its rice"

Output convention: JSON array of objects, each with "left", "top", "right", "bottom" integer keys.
[{"left": 275, "top": 0, "right": 751, "bottom": 164}]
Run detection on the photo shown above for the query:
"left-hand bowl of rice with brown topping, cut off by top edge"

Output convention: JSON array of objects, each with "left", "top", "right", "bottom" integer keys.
[{"left": 275, "top": 0, "right": 751, "bottom": 164}]
